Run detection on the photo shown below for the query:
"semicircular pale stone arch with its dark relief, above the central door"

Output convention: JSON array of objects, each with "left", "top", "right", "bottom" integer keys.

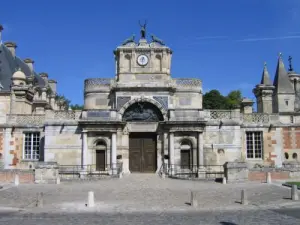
[{"left": 119, "top": 97, "right": 167, "bottom": 122}]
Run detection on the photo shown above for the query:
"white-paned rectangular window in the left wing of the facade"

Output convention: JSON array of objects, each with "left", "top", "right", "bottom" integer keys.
[{"left": 24, "top": 133, "right": 40, "bottom": 160}]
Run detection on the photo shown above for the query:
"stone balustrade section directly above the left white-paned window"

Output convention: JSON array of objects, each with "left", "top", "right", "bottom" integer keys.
[{"left": 7, "top": 114, "right": 45, "bottom": 126}]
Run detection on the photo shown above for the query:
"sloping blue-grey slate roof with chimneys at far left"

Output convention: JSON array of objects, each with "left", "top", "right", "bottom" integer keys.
[{"left": 0, "top": 44, "right": 45, "bottom": 91}]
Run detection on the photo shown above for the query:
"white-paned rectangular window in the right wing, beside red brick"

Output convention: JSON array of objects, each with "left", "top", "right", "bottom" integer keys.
[{"left": 246, "top": 131, "right": 263, "bottom": 159}]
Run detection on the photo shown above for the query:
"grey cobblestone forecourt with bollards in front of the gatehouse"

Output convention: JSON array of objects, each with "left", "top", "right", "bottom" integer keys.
[{"left": 0, "top": 174, "right": 300, "bottom": 225}]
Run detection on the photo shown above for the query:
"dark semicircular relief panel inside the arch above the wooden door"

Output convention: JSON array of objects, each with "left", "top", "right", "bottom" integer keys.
[{"left": 123, "top": 102, "right": 163, "bottom": 122}]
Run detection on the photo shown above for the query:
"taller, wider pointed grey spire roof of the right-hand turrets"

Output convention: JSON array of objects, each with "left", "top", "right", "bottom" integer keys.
[{"left": 273, "top": 57, "right": 295, "bottom": 94}]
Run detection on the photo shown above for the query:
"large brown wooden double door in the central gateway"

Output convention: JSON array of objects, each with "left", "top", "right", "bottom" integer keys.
[{"left": 129, "top": 133, "right": 156, "bottom": 172}]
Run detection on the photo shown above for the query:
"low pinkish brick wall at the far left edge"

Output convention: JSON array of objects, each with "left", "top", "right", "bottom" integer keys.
[{"left": 0, "top": 170, "right": 35, "bottom": 184}]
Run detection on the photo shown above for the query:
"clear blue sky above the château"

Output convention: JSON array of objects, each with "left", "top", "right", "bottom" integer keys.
[{"left": 0, "top": 0, "right": 300, "bottom": 104}]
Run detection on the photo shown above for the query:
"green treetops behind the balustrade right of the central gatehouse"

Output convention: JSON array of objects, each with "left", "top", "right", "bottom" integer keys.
[{"left": 203, "top": 90, "right": 242, "bottom": 109}]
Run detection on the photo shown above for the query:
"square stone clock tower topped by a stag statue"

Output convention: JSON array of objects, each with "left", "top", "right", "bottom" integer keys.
[{"left": 114, "top": 24, "right": 172, "bottom": 84}]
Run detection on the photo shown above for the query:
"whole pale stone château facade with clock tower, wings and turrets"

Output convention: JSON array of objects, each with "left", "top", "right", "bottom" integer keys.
[{"left": 0, "top": 25, "right": 300, "bottom": 176}]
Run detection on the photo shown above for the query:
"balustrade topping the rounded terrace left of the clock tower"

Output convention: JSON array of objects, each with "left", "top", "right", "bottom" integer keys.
[{"left": 84, "top": 78, "right": 114, "bottom": 92}]
